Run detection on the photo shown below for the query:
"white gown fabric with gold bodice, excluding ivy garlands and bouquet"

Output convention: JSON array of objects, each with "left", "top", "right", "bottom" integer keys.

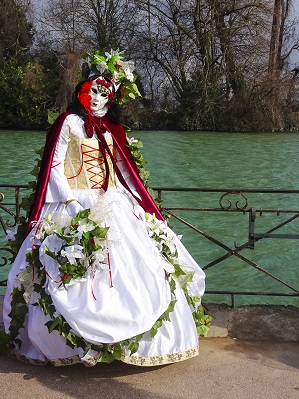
[{"left": 3, "top": 115, "right": 205, "bottom": 366}]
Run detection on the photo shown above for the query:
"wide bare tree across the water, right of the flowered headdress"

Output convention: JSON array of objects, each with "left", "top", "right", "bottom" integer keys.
[{"left": 135, "top": 0, "right": 276, "bottom": 129}]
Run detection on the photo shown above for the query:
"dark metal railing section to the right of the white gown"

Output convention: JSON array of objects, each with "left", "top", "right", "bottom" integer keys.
[{"left": 153, "top": 187, "right": 299, "bottom": 306}]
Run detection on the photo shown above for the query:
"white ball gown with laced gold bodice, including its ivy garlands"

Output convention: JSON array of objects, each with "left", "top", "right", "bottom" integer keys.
[{"left": 3, "top": 114, "right": 209, "bottom": 366}]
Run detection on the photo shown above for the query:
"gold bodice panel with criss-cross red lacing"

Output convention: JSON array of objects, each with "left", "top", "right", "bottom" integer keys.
[{"left": 64, "top": 135, "right": 116, "bottom": 189}]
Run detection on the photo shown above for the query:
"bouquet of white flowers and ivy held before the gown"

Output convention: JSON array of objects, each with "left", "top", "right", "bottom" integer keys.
[{"left": 34, "top": 209, "right": 109, "bottom": 287}]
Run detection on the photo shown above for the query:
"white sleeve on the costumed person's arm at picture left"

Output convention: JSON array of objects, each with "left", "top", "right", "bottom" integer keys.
[{"left": 45, "top": 118, "right": 74, "bottom": 203}]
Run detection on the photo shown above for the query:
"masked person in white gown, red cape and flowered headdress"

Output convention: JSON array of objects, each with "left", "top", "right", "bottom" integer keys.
[{"left": 4, "top": 50, "right": 209, "bottom": 366}]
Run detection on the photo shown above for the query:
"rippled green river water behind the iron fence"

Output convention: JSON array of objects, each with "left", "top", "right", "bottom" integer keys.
[{"left": 0, "top": 130, "right": 299, "bottom": 306}]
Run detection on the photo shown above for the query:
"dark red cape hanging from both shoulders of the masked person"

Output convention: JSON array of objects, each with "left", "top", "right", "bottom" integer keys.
[{"left": 27, "top": 111, "right": 164, "bottom": 234}]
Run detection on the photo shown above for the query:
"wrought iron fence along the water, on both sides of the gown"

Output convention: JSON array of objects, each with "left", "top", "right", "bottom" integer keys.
[{"left": 0, "top": 185, "right": 299, "bottom": 306}]
